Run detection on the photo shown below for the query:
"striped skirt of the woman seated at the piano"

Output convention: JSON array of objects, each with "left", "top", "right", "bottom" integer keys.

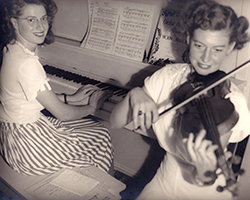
[{"left": 0, "top": 116, "right": 114, "bottom": 175}]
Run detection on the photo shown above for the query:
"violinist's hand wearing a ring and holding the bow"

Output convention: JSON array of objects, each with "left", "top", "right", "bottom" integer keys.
[{"left": 129, "top": 87, "right": 159, "bottom": 132}]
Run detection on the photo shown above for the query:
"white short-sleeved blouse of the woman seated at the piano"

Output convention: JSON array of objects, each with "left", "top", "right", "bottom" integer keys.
[{"left": 0, "top": 42, "right": 51, "bottom": 124}]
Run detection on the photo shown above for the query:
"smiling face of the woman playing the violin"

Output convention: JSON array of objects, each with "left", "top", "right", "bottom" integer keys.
[{"left": 187, "top": 28, "right": 235, "bottom": 76}]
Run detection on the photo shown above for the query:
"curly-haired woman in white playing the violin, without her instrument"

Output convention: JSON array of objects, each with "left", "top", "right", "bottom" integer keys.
[{"left": 110, "top": 0, "right": 250, "bottom": 200}]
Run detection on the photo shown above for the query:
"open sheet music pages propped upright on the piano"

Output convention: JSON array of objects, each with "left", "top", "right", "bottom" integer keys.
[{"left": 81, "top": 0, "right": 155, "bottom": 61}]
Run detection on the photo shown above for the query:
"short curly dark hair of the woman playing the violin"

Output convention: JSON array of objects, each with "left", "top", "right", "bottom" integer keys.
[{"left": 180, "top": 0, "right": 249, "bottom": 49}]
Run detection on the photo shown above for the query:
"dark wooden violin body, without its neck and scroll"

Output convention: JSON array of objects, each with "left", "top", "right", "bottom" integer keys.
[{"left": 172, "top": 71, "right": 239, "bottom": 140}]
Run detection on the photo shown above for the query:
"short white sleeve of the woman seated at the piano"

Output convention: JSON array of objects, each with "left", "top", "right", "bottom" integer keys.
[{"left": 18, "top": 57, "right": 51, "bottom": 100}]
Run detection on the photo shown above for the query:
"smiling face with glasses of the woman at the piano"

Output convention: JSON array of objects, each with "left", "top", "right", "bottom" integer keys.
[{"left": 11, "top": 4, "right": 49, "bottom": 51}]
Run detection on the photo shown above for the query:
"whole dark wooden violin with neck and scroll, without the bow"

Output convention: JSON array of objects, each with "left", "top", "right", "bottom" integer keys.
[{"left": 172, "top": 71, "right": 239, "bottom": 196}]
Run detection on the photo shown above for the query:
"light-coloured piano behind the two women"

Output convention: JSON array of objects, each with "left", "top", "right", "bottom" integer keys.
[{"left": 35, "top": 0, "right": 164, "bottom": 180}]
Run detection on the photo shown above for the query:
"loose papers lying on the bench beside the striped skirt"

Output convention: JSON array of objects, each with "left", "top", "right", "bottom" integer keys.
[{"left": 26, "top": 166, "right": 126, "bottom": 200}]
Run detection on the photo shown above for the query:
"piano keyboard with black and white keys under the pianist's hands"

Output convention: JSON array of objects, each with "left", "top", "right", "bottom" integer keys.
[{"left": 44, "top": 65, "right": 128, "bottom": 120}]
